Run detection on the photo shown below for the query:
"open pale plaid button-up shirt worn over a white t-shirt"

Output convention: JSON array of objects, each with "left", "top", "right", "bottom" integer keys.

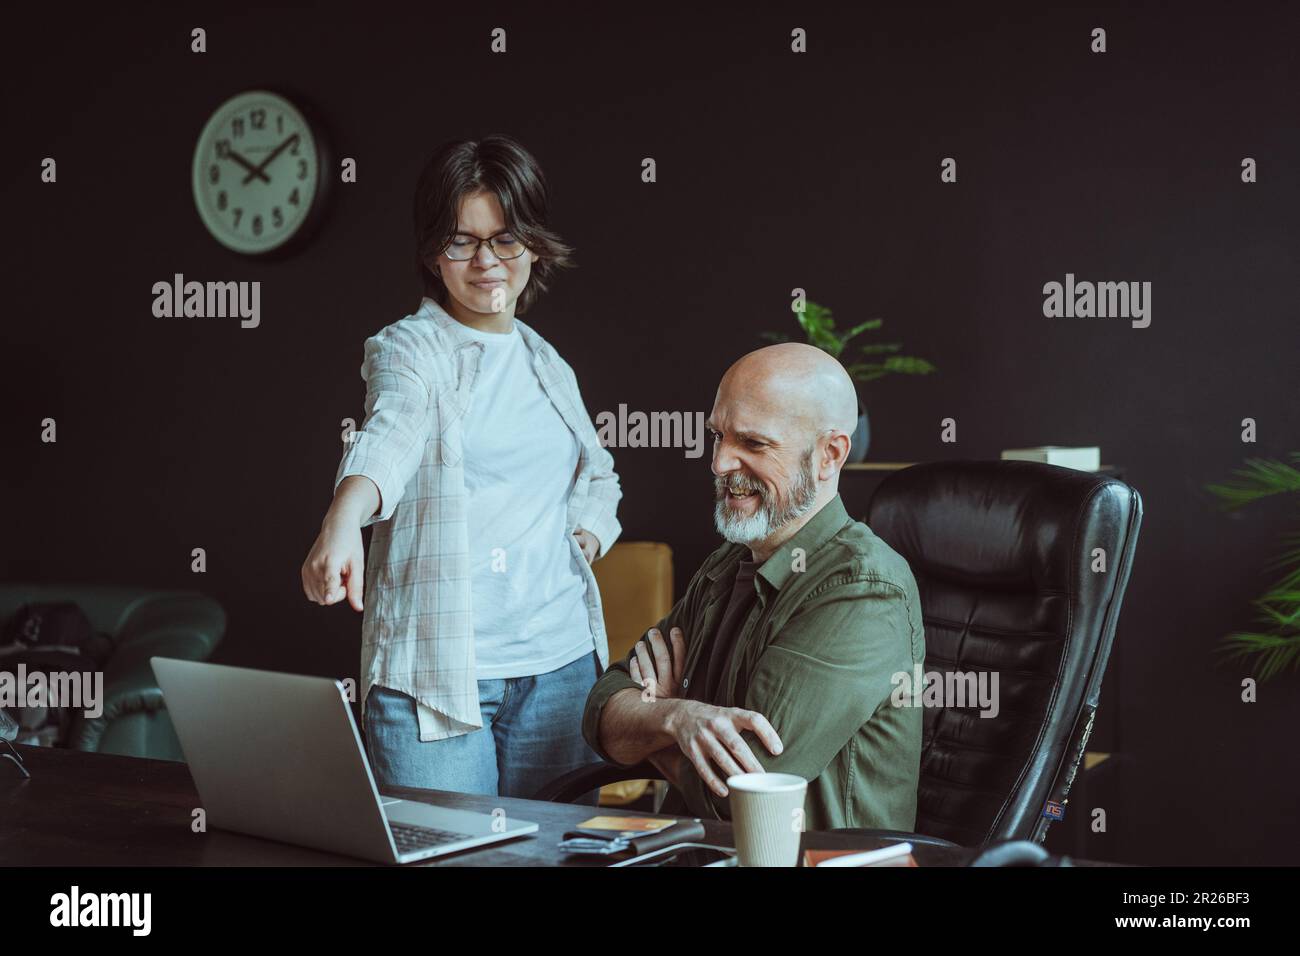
[{"left": 334, "top": 297, "right": 623, "bottom": 740}]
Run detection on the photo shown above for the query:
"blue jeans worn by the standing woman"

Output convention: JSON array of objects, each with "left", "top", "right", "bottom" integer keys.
[{"left": 363, "top": 650, "right": 601, "bottom": 805}]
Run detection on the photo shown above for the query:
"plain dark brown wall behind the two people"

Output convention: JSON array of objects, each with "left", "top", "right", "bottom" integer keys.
[{"left": 0, "top": 4, "right": 1300, "bottom": 864}]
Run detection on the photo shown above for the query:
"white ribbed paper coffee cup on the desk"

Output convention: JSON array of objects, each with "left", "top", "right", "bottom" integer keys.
[{"left": 727, "top": 773, "right": 809, "bottom": 866}]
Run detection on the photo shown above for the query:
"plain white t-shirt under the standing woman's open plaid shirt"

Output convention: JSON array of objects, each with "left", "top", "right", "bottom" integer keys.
[{"left": 462, "top": 326, "right": 595, "bottom": 680}]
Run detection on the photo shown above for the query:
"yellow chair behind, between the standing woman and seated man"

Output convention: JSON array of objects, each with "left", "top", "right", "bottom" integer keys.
[{"left": 592, "top": 541, "right": 672, "bottom": 806}]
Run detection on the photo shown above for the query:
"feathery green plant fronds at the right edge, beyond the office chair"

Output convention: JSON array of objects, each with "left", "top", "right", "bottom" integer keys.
[{"left": 1205, "top": 451, "right": 1300, "bottom": 682}]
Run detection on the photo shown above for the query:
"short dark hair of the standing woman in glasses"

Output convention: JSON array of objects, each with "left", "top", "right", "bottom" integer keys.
[{"left": 415, "top": 133, "right": 573, "bottom": 315}]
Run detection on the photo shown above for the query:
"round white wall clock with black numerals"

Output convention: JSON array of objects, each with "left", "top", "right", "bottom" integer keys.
[{"left": 194, "top": 90, "right": 321, "bottom": 255}]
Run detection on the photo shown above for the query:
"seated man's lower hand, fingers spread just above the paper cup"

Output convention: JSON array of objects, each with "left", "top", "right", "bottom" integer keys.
[{"left": 666, "top": 700, "right": 784, "bottom": 796}]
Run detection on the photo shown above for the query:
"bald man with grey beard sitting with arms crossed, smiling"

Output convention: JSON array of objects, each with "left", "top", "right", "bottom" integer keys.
[{"left": 582, "top": 343, "right": 926, "bottom": 830}]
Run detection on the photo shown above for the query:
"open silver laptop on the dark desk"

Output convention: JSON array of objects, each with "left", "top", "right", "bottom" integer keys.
[{"left": 150, "top": 657, "right": 537, "bottom": 864}]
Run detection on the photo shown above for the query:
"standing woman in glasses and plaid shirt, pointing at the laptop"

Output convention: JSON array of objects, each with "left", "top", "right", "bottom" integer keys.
[{"left": 302, "top": 135, "right": 621, "bottom": 797}]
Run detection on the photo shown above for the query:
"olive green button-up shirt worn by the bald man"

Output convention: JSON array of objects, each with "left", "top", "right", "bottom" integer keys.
[{"left": 582, "top": 496, "right": 926, "bottom": 830}]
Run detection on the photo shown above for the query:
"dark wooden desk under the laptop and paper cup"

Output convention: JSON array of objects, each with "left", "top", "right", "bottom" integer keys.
[{"left": 0, "top": 747, "right": 993, "bottom": 866}]
